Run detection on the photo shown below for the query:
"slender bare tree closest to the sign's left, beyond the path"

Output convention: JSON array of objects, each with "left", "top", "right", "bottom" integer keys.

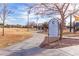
[{"left": 32, "top": 4, "right": 47, "bottom": 30}]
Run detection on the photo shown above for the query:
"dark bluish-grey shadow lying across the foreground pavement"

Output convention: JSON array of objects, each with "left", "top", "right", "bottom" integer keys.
[{"left": 8, "top": 47, "right": 45, "bottom": 56}]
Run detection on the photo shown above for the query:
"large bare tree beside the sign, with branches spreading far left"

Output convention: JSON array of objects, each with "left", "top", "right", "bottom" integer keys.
[{"left": 32, "top": 3, "right": 79, "bottom": 40}]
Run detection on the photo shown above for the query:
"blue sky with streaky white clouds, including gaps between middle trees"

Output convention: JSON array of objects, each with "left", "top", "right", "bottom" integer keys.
[{"left": 0, "top": 3, "right": 47, "bottom": 25}]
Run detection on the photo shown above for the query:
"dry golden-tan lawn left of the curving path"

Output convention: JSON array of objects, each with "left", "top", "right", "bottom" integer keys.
[{"left": 0, "top": 28, "right": 32, "bottom": 48}]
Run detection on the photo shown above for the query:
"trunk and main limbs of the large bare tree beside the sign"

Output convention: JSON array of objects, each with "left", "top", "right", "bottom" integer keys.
[{"left": 43, "top": 3, "right": 79, "bottom": 40}]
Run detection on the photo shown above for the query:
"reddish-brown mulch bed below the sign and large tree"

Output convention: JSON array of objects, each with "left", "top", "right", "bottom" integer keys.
[{"left": 40, "top": 38, "right": 79, "bottom": 49}]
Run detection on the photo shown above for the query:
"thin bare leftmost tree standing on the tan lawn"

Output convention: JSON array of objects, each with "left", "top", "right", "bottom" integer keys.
[{"left": 0, "top": 3, "right": 10, "bottom": 36}]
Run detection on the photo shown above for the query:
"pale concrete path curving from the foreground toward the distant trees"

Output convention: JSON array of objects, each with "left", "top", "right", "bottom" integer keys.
[{"left": 0, "top": 33, "right": 79, "bottom": 56}]
